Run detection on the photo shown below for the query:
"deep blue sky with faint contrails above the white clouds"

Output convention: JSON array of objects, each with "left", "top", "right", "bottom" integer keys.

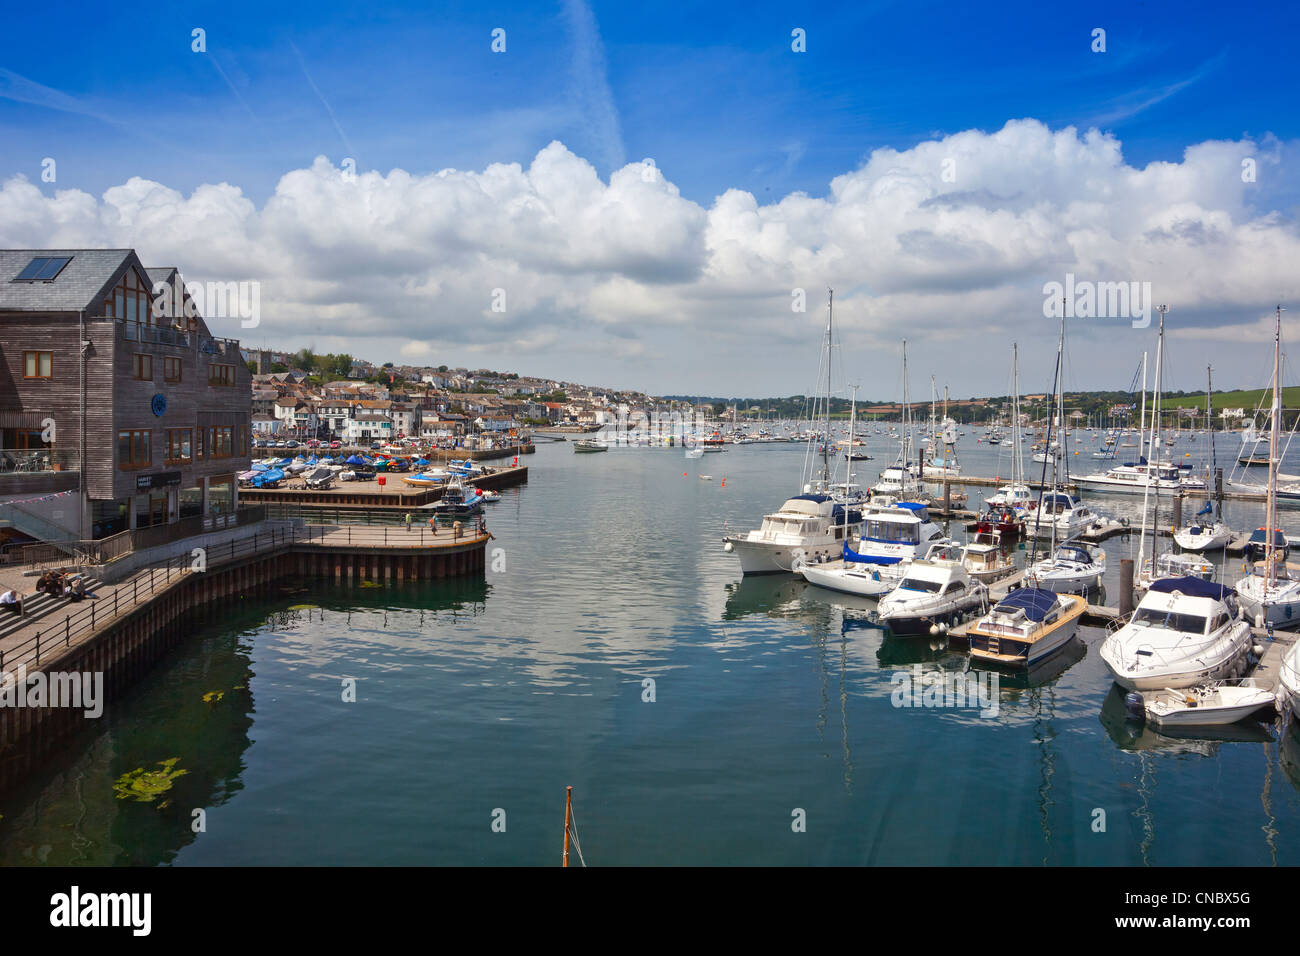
[{"left": 0, "top": 1, "right": 1300, "bottom": 392}]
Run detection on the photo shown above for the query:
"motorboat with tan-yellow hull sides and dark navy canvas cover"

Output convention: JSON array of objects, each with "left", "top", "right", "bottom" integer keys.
[{"left": 966, "top": 588, "right": 1087, "bottom": 670}]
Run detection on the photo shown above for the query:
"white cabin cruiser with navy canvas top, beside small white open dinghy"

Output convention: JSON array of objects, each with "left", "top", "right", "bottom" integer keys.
[{"left": 1101, "top": 578, "right": 1252, "bottom": 691}]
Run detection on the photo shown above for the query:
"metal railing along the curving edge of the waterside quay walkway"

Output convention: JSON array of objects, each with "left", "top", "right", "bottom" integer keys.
[{"left": 0, "top": 518, "right": 490, "bottom": 674}]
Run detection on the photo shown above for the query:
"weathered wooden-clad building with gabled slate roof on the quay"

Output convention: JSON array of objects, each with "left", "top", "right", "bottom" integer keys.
[{"left": 0, "top": 248, "right": 252, "bottom": 540}]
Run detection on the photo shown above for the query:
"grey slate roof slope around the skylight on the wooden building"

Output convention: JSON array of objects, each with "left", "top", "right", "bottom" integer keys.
[{"left": 0, "top": 248, "right": 135, "bottom": 312}]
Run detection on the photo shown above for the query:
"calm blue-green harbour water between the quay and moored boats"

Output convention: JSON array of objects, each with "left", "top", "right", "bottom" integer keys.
[{"left": 0, "top": 429, "right": 1300, "bottom": 865}]
